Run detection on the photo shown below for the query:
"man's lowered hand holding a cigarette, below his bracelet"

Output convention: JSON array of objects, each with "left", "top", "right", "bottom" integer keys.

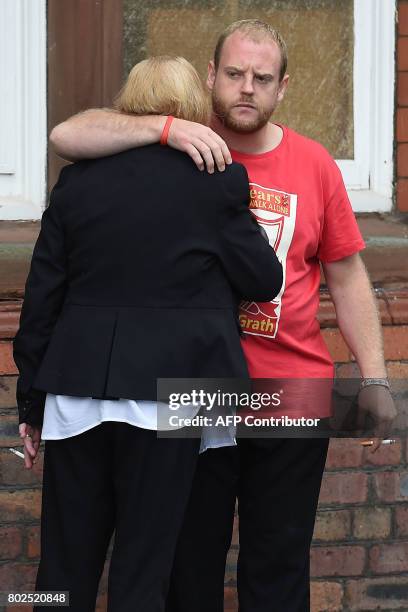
[{"left": 357, "top": 385, "right": 397, "bottom": 453}]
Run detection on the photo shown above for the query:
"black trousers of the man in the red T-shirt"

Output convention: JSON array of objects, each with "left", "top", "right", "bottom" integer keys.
[{"left": 166, "top": 438, "right": 329, "bottom": 612}]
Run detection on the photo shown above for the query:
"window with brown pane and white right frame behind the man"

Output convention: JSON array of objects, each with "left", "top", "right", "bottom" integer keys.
[{"left": 123, "top": 0, "right": 395, "bottom": 212}]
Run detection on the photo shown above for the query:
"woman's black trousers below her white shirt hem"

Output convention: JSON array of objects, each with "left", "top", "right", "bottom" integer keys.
[{"left": 34, "top": 422, "right": 199, "bottom": 612}]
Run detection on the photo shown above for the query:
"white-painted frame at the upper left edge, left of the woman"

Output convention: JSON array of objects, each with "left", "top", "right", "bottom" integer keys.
[{"left": 0, "top": 0, "right": 47, "bottom": 219}]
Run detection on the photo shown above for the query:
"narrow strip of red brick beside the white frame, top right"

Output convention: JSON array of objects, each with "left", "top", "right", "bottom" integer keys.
[{"left": 397, "top": 0, "right": 408, "bottom": 212}]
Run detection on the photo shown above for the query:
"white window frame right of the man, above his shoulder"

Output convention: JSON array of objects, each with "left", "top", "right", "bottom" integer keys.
[{"left": 336, "top": 0, "right": 396, "bottom": 212}]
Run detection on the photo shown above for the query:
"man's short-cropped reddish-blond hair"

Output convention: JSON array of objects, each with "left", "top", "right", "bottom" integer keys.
[{"left": 214, "top": 19, "right": 288, "bottom": 81}]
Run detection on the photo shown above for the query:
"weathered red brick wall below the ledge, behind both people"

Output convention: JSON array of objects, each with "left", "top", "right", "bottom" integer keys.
[{"left": 0, "top": 285, "right": 408, "bottom": 612}]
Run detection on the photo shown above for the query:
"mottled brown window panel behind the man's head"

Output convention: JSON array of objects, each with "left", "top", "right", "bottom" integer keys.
[{"left": 124, "top": 0, "right": 354, "bottom": 159}]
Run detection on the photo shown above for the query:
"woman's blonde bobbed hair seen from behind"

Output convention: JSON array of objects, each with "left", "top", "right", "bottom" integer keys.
[{"left": 114, "top": 55, "right": 209, "bottom": 123}]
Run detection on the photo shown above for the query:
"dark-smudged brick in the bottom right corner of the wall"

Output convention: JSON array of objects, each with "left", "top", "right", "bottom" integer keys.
[{"left": 344, "top": 576, "right": 408, "bottom": 612}]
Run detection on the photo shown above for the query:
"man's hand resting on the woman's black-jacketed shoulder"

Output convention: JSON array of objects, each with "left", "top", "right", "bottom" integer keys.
[{"left": 167, "top": 119, "right": 232, "bottom": 174}]
